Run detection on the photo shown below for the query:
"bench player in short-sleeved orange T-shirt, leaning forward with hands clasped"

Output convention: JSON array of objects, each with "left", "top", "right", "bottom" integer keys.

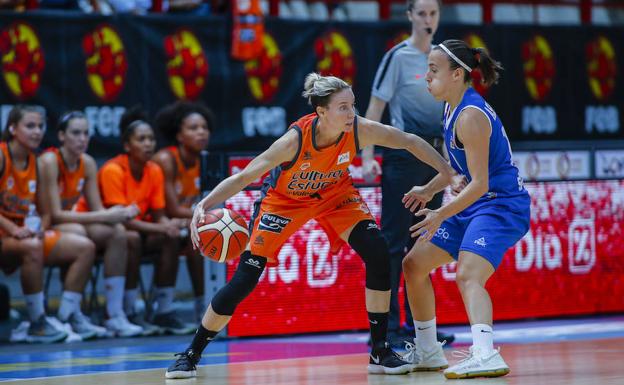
[{"left": 98, "top": 110, "right": 193, "bottom": 334}]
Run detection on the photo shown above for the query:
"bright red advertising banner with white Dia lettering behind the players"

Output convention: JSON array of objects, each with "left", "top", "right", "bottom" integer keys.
[{"left": 227, "top": 162, "right": 624, "bottom": 336}]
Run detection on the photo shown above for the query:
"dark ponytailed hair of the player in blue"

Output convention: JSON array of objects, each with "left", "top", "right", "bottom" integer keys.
[{"left": 434, "top": 39, "right": 503, "bottom": 87}]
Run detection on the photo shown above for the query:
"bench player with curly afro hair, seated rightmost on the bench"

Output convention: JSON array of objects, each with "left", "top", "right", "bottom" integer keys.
[{"left": 153, "top": 101, "right": 214, "bottom": 321}]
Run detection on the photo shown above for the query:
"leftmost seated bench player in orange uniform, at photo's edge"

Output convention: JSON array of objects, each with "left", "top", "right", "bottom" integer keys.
[{"left": 0, "top": 106, "right": 97, "bottom": 342}]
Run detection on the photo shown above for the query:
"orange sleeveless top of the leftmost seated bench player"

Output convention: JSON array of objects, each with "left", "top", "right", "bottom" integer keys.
[{"left": 0, "top": 142, "right": 37, "bottom": 226}]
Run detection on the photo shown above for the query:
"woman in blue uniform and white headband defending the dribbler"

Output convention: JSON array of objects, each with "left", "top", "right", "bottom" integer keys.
[{"left": 403, "top": 40, "right": 531, "bottom": 378}]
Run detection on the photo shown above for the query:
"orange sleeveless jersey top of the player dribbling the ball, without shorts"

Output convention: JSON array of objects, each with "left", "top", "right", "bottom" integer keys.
[{"left": 262, "top": 114, "right": 359, "bottom": 205}]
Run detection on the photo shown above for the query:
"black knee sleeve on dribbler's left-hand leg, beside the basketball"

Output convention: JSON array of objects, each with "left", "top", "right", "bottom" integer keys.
[{"left": 210, "top": 251, "right": 267, "bottom": 315}]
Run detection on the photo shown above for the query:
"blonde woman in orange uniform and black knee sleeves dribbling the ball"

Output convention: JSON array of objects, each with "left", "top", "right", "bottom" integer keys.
[{"left": 165, "top": 73, "right": 452, "bottom": 378}]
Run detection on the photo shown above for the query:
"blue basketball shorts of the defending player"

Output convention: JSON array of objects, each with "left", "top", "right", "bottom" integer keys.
[{"left": 431, "top": 207, "right": 531, "bottom": 269}]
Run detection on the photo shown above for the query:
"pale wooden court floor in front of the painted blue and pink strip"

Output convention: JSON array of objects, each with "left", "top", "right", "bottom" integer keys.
[{"left": 3, "top": 338, "right": 624, "bottom": 385}]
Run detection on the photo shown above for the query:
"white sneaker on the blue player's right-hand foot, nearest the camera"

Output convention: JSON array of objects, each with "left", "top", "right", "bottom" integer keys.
[{"left": 444, "top": 346, "right": 509, "bottom": 378}]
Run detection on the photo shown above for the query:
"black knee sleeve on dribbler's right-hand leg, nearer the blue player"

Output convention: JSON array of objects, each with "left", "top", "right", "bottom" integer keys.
[{"left": 349, "top": 220, "right": 390, "bottom": 291}]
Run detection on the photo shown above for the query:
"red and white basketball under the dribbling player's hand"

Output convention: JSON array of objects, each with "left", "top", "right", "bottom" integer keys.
[{"left": 197, "top": 209, "right": 249, "bottom": 262}]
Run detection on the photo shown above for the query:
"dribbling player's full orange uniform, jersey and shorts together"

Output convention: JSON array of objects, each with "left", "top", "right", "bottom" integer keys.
[{"left": 249, "top": 114, "right": 374, "bottom": 266}]
